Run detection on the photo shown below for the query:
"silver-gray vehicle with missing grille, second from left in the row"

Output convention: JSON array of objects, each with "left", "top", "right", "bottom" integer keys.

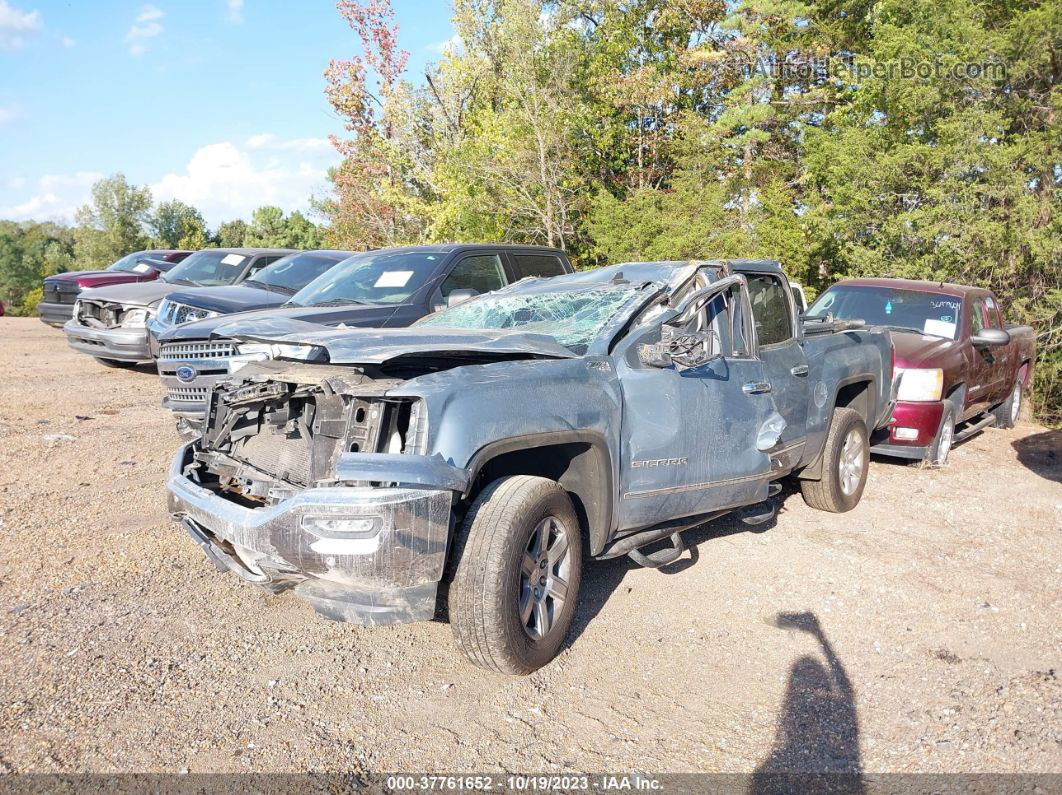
[{"left": 63, "top": 248, "right": 292, "bottom": 367}]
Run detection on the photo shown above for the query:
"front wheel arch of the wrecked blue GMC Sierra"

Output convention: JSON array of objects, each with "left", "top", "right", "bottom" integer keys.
[{"left": 466, "top": 431, "right": 615, "bottom": 555}]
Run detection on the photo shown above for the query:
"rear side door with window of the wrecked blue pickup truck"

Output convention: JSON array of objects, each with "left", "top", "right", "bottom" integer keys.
[{"left": 744, "top": 273, "right": 809, "bottom": 461}]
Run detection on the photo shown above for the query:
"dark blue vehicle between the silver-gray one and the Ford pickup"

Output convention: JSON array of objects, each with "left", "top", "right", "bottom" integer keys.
[{"left": 148, "top": 249, "right": 354, "bottom": 355}]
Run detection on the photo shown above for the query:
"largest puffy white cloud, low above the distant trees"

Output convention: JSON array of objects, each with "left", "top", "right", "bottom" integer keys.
[{"left": 151, "top": 134, "right": 339, "bottom": 226}]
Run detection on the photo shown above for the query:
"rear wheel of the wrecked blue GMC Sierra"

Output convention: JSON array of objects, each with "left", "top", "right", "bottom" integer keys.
[{"left": 800, "top": 409, "right": 870, "bottom": 514}]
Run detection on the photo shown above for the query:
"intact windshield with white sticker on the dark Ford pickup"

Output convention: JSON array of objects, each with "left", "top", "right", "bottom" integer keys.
[{"left": 291, "top": 252, "right": 447, "bottom": 307}]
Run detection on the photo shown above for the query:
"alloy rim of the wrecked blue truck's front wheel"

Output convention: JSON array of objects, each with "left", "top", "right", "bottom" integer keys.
[{"left": 517, "top": 516, "right": 571, "bottom": 640}]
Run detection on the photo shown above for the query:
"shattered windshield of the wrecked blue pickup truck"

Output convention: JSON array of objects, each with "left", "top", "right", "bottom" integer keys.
[{"left": 415, "top": 283, "right": 638, "bottom": 355}]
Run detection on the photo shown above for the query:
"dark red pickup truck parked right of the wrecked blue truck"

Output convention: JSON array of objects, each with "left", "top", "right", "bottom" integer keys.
[{"left": 807, "top": 279, "right": 1035, "bottom": 465}]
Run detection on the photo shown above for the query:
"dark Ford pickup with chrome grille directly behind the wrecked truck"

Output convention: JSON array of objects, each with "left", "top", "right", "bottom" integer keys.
[{"left": 156, "top": 243, "right": 572, "bottom": 420}]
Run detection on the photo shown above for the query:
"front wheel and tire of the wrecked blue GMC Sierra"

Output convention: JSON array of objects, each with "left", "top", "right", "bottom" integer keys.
[{"left": 448, "top": 474, "right": 582, "bottom": 675}]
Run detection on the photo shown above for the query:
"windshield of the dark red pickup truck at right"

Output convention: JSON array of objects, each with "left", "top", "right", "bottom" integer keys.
[{"left": 806, "top": 284, "right": 962, "bottom": 340}]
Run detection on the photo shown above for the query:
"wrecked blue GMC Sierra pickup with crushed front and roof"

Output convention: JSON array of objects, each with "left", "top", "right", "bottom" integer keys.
[{"left": 168, "top": 261, "right": 891, "bottom": 674}]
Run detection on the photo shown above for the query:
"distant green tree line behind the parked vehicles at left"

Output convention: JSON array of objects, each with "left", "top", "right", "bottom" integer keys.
[{"left": 0, "top": 174, "right": 324, "bottom": 315}]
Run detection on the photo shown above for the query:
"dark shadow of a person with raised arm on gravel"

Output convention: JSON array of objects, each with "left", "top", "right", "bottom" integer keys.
[{"left": 750, "top": 611, "right": 866, "bottom": 795}]
